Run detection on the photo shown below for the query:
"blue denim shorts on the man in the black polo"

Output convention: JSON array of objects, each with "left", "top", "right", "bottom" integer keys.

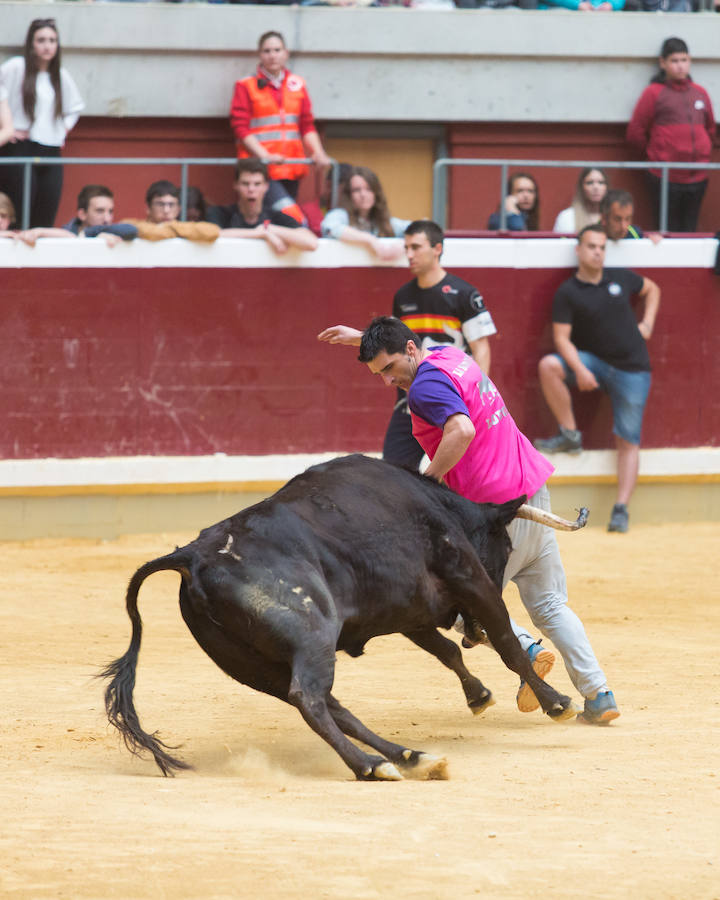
[{"left": 555, "top": 350, "right": 651, "bottom": 444}]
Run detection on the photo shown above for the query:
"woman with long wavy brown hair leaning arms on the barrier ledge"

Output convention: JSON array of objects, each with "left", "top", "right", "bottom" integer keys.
[{"left": 321, "top": 166, "right": 410, "bottom": 260}]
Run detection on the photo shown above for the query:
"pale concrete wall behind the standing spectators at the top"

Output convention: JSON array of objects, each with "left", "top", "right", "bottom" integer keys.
[{"left": 0, "top": 2, "right": 720, "bottom": 122}]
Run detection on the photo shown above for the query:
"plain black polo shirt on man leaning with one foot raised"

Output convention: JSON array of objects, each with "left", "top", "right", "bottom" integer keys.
[{"left": 552, "top": 269, "right": 650, "bottom": 372}]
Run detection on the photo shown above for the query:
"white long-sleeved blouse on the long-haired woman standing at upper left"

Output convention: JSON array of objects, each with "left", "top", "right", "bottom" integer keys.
[{"left": 0, "top": 56, "right": 85, "bottom": 147}]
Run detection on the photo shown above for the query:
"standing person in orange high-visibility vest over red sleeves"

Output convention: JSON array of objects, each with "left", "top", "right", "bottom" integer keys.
[{"left": 230, "top": 31, "right": 330, "bottom": 197}]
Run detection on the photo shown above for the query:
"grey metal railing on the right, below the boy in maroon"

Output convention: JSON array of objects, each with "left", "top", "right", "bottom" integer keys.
[{"left": 432, "top": 158, "right": 720, "bottom": 231}]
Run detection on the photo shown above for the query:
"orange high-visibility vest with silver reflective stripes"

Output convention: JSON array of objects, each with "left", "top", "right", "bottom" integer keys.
[{"left": 238, "top": 72, "right": 307, "bottom": 181}]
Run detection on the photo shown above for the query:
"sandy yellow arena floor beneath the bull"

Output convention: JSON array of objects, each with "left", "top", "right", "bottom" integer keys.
[{"left": 0, "top": 524, "right": 720, "bottom": 900}]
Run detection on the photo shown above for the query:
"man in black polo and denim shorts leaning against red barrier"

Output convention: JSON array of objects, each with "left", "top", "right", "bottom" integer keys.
[{"left": 534, "top": 225, "right": 660, "bottom": 532}]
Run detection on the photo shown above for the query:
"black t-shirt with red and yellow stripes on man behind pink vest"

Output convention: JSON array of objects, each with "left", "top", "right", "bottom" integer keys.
[{"left": 393, "top": 275, "right": 497, "bottom": 352}]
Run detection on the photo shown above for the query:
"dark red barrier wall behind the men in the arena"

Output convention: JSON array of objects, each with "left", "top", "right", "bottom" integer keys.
[{"left": 0, "top": 242, "right": 720, "bottom": 459}]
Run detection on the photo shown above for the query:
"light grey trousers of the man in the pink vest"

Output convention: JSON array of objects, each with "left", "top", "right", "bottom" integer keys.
[{"left": 503, "top": 485, "right": 606, "bottom": 697}]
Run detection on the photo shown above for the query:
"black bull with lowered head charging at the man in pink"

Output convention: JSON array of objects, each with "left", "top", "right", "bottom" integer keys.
[{"left": 101, "top": 456, "right": 584, "bottom": 780}]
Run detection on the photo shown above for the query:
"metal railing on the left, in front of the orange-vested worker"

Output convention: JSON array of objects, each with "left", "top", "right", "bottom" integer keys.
[{"left": 0, "top": 156, "right": 340, "bottom": 230}]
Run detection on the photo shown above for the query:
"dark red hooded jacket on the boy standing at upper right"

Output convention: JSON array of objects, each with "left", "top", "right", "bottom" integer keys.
[{"left": 627, "top": 79, "right": 715, "bottom": 184}]
